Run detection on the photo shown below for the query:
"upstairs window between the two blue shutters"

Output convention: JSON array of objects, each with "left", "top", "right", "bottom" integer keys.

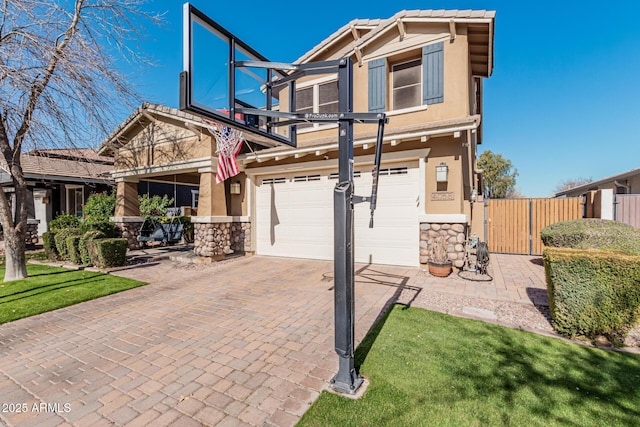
[{"left": 391, "top": 58, "right": 422, "bottom": 110}]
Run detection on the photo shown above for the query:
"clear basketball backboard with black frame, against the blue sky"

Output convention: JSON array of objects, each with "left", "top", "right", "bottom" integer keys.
[{"left": 180, "top": 3, "right": 296, "bottom": 147}]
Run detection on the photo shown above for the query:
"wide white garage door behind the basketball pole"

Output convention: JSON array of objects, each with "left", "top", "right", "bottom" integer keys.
[{"left": 256, "top": 162, "right": 419, "bottom": 266}]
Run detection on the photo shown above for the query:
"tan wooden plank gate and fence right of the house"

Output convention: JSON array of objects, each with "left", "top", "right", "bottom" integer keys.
[{"left": 485, "top": 197, "right": 583, "bottom": 255}]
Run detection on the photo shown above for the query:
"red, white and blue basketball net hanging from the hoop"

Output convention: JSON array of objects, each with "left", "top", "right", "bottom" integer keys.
[{"left": 202, "top": 119, "right": 244, "bottom": 184}]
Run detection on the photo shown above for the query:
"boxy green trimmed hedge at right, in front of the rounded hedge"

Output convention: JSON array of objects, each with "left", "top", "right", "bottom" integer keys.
[{"left": 543, "top": 248, "right": 640, "bottom": 345}]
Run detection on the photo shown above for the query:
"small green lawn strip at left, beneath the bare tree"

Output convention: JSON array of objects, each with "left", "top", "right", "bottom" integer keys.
[{"left": 0, "top": 264, "right": 145, "bottom": 324}]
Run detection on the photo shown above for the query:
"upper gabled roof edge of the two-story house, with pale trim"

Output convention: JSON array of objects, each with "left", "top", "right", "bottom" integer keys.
[{"left": 296, "top": 9, "right": 496, "bottom": 77}]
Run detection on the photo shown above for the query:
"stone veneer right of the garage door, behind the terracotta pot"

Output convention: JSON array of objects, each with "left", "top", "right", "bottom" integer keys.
[{"left": 420, "top": 223, "right": 467, "bottom": 268}]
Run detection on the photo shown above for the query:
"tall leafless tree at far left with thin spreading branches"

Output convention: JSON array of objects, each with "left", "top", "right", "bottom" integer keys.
[{"left": 0, "top": 0, "right": 160, "bottom": 281}]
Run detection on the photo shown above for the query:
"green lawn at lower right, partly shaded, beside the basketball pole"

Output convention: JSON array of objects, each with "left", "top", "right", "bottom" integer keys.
[{"left": 299, "top": 306, "right": 640, "bottom": 427}]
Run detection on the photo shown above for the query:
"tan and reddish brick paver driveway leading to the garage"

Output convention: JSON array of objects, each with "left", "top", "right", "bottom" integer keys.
[{"left": 0, "top": 257, "right": 417, "bottom": 426}]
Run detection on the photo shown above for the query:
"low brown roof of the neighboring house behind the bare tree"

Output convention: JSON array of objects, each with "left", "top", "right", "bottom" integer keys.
[{"left": 0, "top": 154, "right": 113, "bottom": 184}]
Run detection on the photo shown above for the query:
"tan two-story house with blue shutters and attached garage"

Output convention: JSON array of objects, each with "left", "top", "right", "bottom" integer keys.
[{"left": 102, "top": 10, "right": 495, "bottom": 267}]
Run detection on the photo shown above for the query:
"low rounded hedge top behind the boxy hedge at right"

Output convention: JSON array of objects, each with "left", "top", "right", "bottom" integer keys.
[{"left": 540, "top": 219, "right": 640, "bottom": 255}]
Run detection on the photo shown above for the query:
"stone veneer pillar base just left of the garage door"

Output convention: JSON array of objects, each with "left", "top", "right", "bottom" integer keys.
[{"left": 193, "top": 222, "right": 251, "bottom": 258}]
